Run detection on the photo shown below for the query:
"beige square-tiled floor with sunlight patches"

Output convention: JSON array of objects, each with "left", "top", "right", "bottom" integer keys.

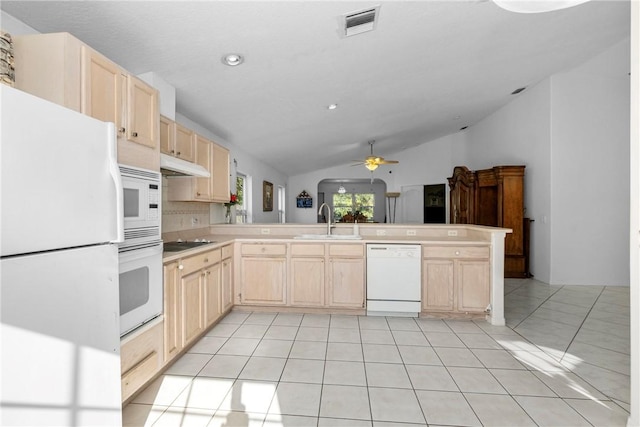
[{"left": 123, "top": 279, "right": 629, "bottom": 427}]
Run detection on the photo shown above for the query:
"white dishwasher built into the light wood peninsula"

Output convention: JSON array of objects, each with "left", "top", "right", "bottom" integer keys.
[{"left": 367, "top": 243, "right": 421, "bottom": 317}]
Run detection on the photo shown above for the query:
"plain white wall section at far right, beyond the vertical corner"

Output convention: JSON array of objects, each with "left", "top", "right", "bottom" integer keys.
[{"left": 550, "top": 40, "right": 630, "bottom": 285}]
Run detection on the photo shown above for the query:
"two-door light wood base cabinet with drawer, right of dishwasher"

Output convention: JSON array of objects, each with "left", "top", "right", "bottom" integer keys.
[{"left": 422, "top": 245, "right": 491, "bottom": 313}]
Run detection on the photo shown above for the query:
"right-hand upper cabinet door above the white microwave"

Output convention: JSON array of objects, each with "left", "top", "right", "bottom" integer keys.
[{"left": 126, "top": 75, "right": 159, "bottom": 148}]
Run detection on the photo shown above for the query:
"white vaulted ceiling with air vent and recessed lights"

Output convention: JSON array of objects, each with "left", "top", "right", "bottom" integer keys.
[{"left": 0, "top": 0, "right": 630, "bottom": 175}]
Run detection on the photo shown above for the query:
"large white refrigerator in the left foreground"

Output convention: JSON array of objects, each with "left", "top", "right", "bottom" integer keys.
[{"left": 0, "top": 85, "right": 124, "bottom": 426}]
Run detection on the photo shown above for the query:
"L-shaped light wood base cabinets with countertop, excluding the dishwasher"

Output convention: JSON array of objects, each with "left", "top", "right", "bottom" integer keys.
[{"left": 122, "top": 224, "right": 511, "bottom": 401}]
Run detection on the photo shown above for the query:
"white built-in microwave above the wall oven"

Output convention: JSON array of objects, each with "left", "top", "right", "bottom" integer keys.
[{"left": 120, "top": 165, "right": 162, "bottom": 246}]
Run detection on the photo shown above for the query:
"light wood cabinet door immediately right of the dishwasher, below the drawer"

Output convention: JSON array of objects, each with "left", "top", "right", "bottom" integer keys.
[{"left": 422, "top": 259, "right": 455, "bottom": 311}]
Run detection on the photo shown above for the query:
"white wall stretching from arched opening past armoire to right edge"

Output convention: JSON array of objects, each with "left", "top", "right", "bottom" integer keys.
[{"left": 288, "top": 40, "right": 630, "bottom": 286}]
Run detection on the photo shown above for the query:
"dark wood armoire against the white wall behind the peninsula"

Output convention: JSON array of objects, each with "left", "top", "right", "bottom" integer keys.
[{"left": 449, "top": 166, "right": 531, "bottom": 277}]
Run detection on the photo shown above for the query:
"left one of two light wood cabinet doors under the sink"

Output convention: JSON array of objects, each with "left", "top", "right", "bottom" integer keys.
[{"left": 289, "top": 258, "right": 325, "bottom": 307}]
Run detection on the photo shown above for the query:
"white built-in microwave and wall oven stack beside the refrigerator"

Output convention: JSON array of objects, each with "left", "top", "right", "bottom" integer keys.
[{"left": 118, "top": 165, "right": 163, "bottom": 336}]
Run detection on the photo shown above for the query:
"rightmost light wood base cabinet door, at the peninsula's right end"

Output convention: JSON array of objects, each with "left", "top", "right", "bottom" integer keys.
[{"left": 456, "top": 260, "right": 491, "bottom": 313}]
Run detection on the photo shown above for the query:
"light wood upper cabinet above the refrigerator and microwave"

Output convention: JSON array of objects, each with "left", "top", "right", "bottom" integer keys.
[{"left": 14, "top": 33, "right": 160, "bottom": 171}]
